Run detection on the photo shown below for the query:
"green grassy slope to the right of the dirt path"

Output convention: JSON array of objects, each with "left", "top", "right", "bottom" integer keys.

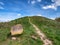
[{"left": 30, "top": 16, "right": 60, "bottom": 45}]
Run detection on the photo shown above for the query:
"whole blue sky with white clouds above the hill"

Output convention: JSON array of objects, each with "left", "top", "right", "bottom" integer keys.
[{"left": 0, "top": 0, "right": 60, "bottom": 22}]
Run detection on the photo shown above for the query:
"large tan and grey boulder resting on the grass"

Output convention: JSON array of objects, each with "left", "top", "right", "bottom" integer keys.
[{"left": 11, "top": 24, "right": 23, "bottom": 35}]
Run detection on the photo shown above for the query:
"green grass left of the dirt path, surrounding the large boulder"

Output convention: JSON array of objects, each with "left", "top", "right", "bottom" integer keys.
[{"left": 0, "top": 17, "right": 43, "bottom": 45}]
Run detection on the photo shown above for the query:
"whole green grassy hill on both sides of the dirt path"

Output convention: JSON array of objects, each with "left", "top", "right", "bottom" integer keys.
[{"left": 0, "top": 16, "right": 60, "bottom": 45}]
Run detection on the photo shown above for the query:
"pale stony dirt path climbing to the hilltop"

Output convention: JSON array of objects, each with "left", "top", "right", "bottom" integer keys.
[{"left": 28, "top": 17, "right": 52, "bottom": 45}]
